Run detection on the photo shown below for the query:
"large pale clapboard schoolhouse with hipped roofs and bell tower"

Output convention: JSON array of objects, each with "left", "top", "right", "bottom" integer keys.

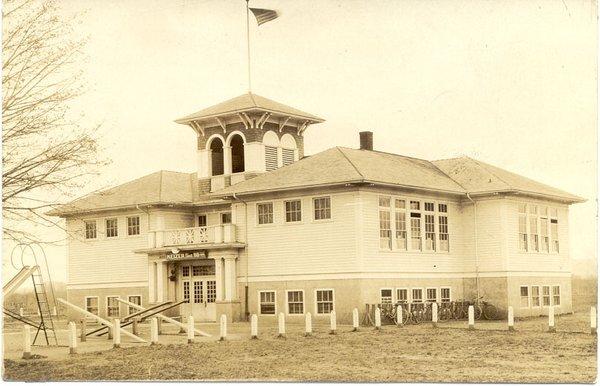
[{"left": 52, "top": 93, "right": 583, "bottom": 321}]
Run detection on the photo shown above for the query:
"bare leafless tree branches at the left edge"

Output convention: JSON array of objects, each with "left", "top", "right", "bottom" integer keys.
[{"left": 2, "top": 0, "right": 104, "bottom": 242}]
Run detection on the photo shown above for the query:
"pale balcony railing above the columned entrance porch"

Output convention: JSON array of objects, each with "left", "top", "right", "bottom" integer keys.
[{"left": 148, "top": 224, "right": 235, "bottom": 248}]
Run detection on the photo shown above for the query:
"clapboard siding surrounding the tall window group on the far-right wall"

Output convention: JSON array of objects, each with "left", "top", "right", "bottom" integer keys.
[{"left": 506, "top": 198, "right": 571, "bottom": 272}]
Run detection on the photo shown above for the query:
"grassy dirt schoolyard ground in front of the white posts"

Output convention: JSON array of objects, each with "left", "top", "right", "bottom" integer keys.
[{"left": 3, "top": 313, "right": 597, "bottom": 383}]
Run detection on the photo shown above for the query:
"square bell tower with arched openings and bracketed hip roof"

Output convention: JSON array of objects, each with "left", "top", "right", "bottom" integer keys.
[{"left": 175, "top": 93, "right": 324, "bottom": 194}]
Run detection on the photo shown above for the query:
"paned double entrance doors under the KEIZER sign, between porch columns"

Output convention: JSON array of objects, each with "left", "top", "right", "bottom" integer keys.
[{"left": 181, "top": 263, "right": 217, "bottom": 322}]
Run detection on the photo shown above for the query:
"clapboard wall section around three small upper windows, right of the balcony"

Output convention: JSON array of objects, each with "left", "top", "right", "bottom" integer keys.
[{"left": 243, "top": 192, "right": 357, "bottom": 276}]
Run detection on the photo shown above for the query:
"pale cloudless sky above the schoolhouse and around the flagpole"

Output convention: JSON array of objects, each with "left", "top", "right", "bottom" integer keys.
[{"left": 4, "top": 0, "right": 597, "bottom": 280}]
